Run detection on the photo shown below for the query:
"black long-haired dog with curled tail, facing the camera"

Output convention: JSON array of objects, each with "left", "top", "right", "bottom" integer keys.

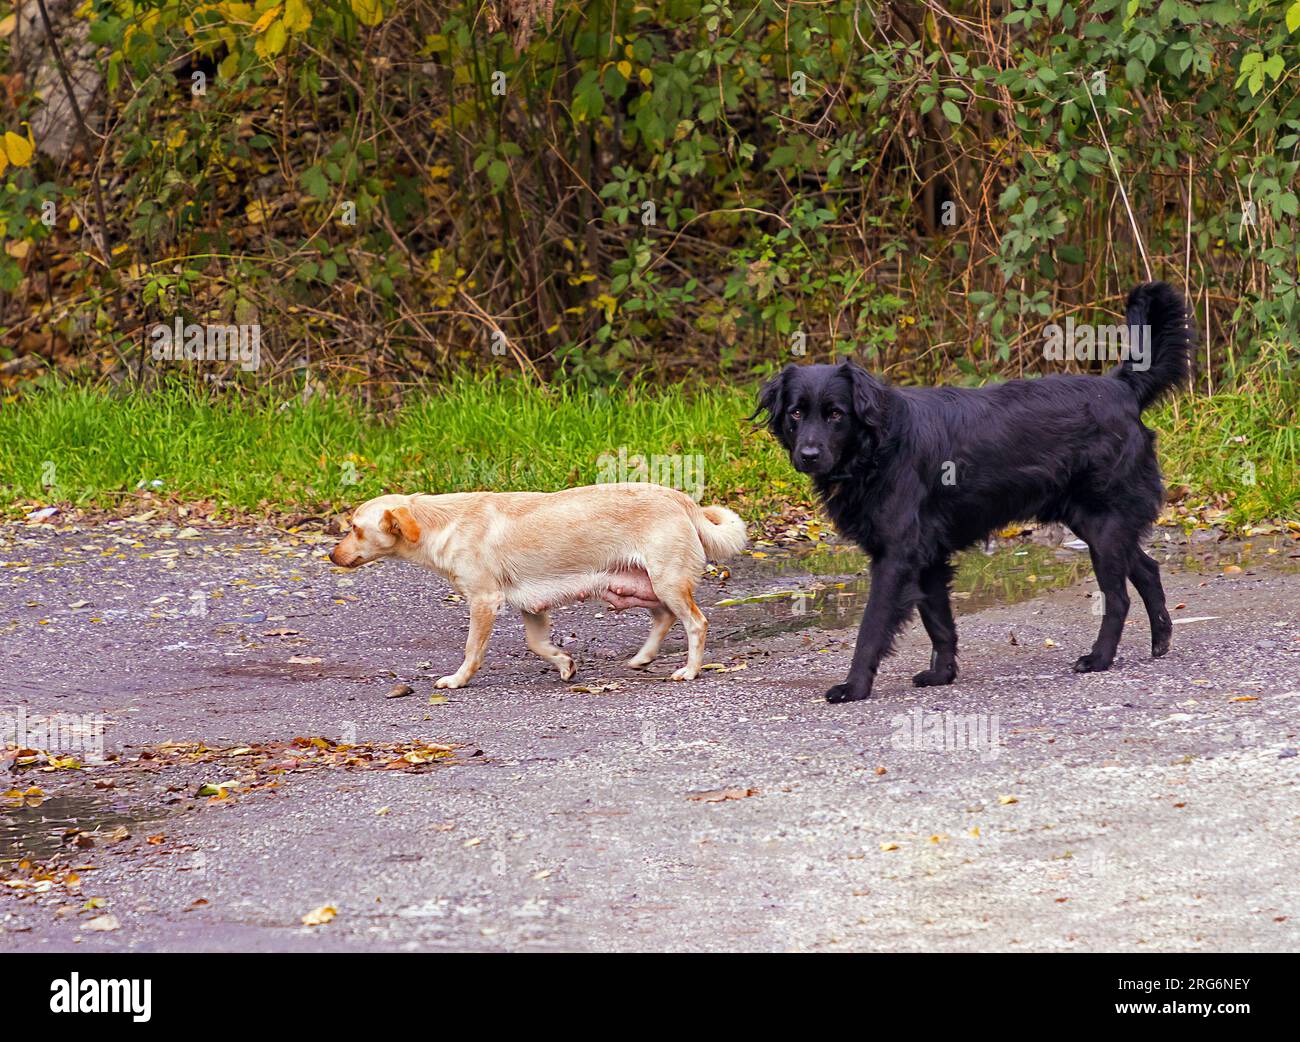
[{"left": 754, "top": 282, "right": 1195, "bottom": 702}]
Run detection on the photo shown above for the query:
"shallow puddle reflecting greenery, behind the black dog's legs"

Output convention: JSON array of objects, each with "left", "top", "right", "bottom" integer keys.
[{"left": 714, "top": 537, "right": 1300, "bottom": 643}]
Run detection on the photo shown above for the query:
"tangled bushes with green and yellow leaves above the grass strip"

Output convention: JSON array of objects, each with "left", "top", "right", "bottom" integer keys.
[{"left": 0, "top": 0, "right": 1300, "bottom": 379}]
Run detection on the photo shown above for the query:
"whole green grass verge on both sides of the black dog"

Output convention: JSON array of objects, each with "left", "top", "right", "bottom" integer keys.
[{"left": 0, "top": 361, "right": 1300, "bottom": 524}]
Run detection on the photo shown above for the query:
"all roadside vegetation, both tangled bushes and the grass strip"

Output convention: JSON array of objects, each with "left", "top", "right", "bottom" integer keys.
[{"left": 0, "top": 0, "right": 1300, "bottom": 525}]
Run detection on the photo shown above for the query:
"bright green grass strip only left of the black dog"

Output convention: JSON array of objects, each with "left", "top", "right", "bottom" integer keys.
[{"left": 0, "top": 377, "right": 807, "bottom": 516}]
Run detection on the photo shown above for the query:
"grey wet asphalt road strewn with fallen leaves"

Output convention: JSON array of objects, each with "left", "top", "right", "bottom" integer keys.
[{"left": 0, "top": 522, "right": 1300, "bottom": 951}]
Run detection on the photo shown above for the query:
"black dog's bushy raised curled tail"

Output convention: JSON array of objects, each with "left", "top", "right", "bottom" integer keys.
[{"left": 1112, "top": 282, "right": 1196, "bottom": 409}]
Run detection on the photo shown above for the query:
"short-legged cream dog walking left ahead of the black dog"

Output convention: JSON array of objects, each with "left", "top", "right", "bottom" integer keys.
[{"left": 329, "top": 482, "right": 745, "bottom": 687}]
